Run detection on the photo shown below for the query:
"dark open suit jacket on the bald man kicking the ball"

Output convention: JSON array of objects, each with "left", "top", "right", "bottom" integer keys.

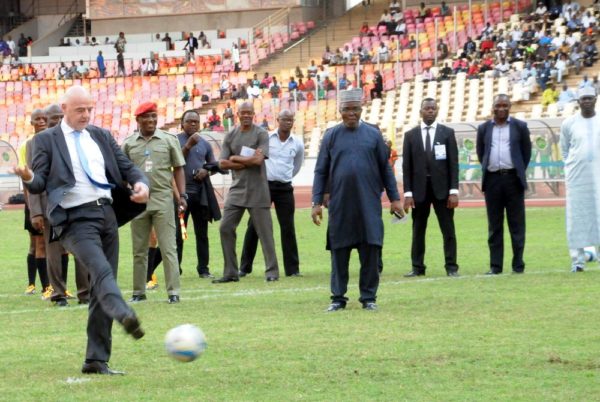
[{"left": 26, "top": 125, "right": 148, "bottom": 236}]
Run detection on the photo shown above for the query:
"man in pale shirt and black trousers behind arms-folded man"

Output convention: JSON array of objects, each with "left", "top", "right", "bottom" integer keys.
[{"left": 240, "top": 109, "right": 304, "bottom": 276}]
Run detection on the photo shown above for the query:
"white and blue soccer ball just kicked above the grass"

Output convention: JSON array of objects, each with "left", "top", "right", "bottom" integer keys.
[{"left": 165, "top": 324, "right": 206, "bottom": 362}]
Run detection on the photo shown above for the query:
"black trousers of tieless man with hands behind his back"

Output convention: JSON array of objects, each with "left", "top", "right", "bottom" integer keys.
[{"left": 485, "top": 170, "right": 525, "bottom": 273}]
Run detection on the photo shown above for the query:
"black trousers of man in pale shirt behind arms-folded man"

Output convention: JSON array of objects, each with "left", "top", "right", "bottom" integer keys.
[{"left": 240, "top": 181, "right": 300, "bottom": 276}]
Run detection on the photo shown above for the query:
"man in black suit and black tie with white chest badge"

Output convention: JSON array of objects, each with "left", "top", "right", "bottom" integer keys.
[{"left": 402, "top": 98, "right": 458, "bottom": 277}]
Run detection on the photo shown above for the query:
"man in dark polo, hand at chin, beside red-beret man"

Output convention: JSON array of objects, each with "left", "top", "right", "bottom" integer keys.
[{"left": 177, "top": 110, "right": 221, "bottom": 278}]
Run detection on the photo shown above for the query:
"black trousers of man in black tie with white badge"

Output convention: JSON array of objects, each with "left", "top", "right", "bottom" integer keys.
[{"left": 410, "top": 178, "right": 458, "bottom": 274}]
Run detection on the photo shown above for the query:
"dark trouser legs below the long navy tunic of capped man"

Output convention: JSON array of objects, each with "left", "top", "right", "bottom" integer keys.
[{"left": 331, "top": 244, "right": 381, "bottom": 305}]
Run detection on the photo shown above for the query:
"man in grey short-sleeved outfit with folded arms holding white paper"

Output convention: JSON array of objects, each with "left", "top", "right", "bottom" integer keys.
[{"left": 213, "top": 102, "right": 279, "bottom": 283}]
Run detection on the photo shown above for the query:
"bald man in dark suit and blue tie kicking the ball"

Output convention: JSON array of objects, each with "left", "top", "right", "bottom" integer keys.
[{"left": 14, "top": 86, "right": 148, "bottom": 374}]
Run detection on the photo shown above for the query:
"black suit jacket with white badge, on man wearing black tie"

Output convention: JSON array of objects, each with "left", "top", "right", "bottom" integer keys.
[{"left": 402, "top": 123, "right": 458, "bottom": 202}]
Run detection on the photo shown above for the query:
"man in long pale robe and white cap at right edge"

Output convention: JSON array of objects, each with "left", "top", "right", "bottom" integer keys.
[{"left": 560, "top": 87, "right": 600, "bottom": 272}]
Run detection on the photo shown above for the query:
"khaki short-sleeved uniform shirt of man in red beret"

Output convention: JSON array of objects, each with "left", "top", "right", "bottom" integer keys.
[{"left": 122, "top": 130, "right": 185, "bottom": 211}]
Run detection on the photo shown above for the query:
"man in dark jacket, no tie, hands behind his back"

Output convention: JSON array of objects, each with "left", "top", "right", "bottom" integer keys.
[{"left": 477, "top": 94, "right": 531, "bottom": 275}]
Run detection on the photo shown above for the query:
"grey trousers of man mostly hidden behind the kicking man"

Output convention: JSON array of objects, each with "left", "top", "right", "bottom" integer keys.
[{"left": 44, "top": 218, "right": 90, "bottom": 302}]
